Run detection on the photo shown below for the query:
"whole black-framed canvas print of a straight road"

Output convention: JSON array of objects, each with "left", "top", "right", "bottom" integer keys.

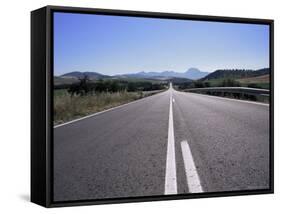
[{"left": 31, "top": 6, "right": 274, "bottom": 207}]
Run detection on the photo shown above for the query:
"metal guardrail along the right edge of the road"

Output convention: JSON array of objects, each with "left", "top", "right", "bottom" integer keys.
[{"left": 184, "top": 87, "right": 270, "bottom": 97}]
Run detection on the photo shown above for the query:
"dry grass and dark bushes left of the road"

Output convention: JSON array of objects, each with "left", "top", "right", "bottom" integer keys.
[{"left": 54, "top": 76, "right": 167, "bottom": 125}]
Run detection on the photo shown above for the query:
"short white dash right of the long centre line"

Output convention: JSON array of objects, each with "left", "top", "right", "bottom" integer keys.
[{"left": 181, "top": 141, "right": 203, "bottom": 193}]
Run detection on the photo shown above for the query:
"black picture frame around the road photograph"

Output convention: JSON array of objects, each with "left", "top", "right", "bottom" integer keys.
[{"left": 31, "top": 6, "right": 274, "bottom": 207}]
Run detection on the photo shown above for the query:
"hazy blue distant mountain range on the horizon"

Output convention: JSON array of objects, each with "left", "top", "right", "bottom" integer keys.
[{"left": 60, "top": 68, "right": 209, "bottom": 80}]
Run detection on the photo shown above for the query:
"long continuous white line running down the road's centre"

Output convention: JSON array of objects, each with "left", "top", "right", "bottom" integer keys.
[{"left": 165, "top": 92, "right": 177, "bottom": 195}]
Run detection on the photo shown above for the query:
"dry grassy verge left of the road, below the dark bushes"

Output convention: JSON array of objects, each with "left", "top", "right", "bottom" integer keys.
[{"left": 54, "top": 89, "right": 161, "bottom": 125}]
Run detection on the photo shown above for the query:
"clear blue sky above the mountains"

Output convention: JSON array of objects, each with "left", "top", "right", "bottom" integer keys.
[{"left": 54, "top": 12, "right": 269, "bottom": 75}]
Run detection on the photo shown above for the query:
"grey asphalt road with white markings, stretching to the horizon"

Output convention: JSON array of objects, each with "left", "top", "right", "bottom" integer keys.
[{"left": 54, "top": 84, "right": 269, "bottom": 201}]
